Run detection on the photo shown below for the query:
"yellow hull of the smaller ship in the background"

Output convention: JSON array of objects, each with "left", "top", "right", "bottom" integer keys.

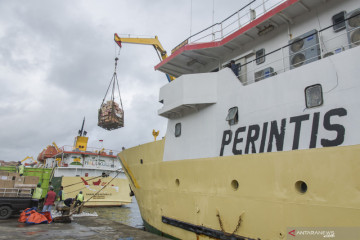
[{"left": 61, "top": 177, "right": 131, "bottom": 207}]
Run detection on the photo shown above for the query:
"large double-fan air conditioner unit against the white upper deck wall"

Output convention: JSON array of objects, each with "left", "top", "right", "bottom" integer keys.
[{"left": 289, "top": 29, "right": 321, "bottom": 69}]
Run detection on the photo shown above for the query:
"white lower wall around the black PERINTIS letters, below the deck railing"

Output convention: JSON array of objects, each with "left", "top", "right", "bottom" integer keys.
[{"left": 163, "top": 45, "right": 360, "bottom": 161}]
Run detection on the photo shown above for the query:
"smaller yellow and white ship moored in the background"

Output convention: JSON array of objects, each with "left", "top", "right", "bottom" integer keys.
[{"left": 39, "top": 118, "right": 132, "bottom": 207}]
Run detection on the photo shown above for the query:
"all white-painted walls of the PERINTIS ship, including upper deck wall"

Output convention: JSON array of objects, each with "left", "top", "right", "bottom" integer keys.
[{"left": 159, "top": 0, "right": 360, "bottom": 161}]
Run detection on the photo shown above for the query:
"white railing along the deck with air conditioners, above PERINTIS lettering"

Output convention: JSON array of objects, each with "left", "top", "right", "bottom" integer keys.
[{"left": 238, "top": 25, "right": 360, "bottom": 85}]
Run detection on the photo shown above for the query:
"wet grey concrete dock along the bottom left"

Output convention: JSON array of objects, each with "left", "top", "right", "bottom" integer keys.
[{"left": 0, "top": 216, "right": 167, "bottom": 240}]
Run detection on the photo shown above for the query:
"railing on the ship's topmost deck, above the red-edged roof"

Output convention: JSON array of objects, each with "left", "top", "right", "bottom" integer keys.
[{"left": 176, "top": 0, "right": 287, "bottom": 47}]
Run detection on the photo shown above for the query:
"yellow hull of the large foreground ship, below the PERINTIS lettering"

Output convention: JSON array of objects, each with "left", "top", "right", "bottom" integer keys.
[{"left": 118, "top": 140, "right": 360, "bottom": 239}]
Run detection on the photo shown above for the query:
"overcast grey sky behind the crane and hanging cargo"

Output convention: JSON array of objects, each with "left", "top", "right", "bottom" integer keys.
[{"left": 0, "top": 0, "right": 253, "bottom": 161}]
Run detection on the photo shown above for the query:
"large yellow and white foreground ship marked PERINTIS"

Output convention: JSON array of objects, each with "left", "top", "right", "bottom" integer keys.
[{"left": 118, "top": 0, "right": 360, "bottom": 240}]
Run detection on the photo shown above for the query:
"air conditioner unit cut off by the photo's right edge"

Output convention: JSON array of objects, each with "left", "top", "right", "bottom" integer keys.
[{"left": 346, "top": 8, "right": 360, "bottom": 48}]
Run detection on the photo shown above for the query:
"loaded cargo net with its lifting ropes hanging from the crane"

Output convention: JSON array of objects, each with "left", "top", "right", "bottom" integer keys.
[{"left": 98, "top": 58, "right": 124, "bottom": 130}]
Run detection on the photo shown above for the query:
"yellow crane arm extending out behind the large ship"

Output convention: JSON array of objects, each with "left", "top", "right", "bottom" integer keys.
[{"left": 114, "top": 33, "right": 175, "bottom": 82}]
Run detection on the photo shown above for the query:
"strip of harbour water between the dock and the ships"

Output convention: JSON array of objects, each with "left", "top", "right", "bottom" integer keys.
[{"left": 83, "top": 197, "right": 144, "bottom": 229}]
